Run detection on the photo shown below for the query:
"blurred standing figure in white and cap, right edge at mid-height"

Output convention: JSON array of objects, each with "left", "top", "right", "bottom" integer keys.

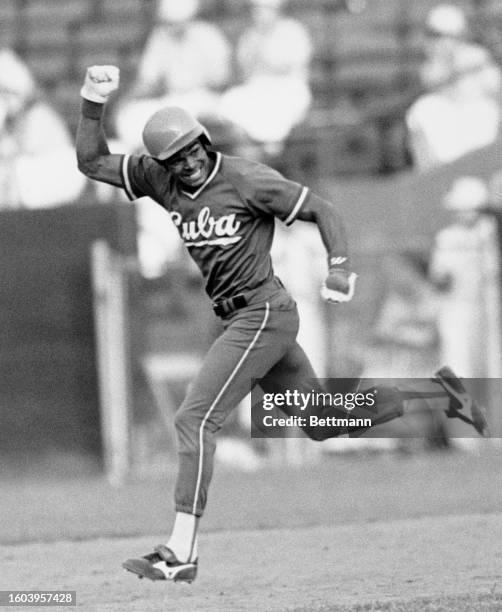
[{"left": 431, "top": 176, "right": 502, "bottom": 378}]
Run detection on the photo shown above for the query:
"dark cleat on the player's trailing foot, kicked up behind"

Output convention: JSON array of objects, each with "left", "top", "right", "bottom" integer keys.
[{"left": 434, "top": 366, "right": 490, "bottom": 438}]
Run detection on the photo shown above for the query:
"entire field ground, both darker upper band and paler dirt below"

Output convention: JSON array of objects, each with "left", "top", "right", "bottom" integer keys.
[{"left": 0, "top": 443, "right": 502, "bottom": 612}]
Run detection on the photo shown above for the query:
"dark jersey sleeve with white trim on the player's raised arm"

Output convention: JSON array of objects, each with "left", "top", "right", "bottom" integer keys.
[{"left": 120, "top": 155, "right": 169, "bottom": 203}]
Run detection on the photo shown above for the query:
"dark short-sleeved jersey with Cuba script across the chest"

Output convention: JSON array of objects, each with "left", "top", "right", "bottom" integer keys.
[{"left": 121, "top": 153, "right": 310, "bottom": 301}]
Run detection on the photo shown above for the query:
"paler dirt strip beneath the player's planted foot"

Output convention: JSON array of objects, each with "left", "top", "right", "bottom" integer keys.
[{"left": 1, "top": 514, "right": 502, "bottom": 612}]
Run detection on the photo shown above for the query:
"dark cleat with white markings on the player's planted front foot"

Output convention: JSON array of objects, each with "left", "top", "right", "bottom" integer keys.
[{"left": 122, "top": 544, "right": 197, "bottom": 582}]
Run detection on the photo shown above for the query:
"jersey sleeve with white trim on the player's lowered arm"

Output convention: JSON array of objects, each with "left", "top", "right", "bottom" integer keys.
[{"left": 246, "top": 166, "right": 310, "bottom": 225}]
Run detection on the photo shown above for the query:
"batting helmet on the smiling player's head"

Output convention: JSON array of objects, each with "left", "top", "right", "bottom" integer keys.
[{"left": 143, "top": 106, "right": 211, "bottom": 160}]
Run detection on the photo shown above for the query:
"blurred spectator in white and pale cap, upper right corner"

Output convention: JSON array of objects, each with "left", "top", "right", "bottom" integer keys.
[{"left": 407, "top": 4, "right": 502, "bottom": 169}]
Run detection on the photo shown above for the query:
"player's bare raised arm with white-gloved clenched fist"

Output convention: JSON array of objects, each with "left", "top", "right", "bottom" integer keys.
[{"left": 76, "top": 66, "right": 123, "bottom": 187}]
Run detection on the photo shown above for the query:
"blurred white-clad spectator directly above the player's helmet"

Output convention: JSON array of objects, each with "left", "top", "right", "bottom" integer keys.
[{"left": 116, "top": 0, "right": 231, "bottom": 151}]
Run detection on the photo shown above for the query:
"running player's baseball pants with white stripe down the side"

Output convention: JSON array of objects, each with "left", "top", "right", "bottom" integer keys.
[{"left": 175, "top": 281, "right": 400, "bottom": 516}]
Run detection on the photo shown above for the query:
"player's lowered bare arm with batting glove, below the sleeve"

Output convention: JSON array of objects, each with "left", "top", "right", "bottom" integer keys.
[{"left": 296, "top": 193, "right": 357, "bottom": 304}]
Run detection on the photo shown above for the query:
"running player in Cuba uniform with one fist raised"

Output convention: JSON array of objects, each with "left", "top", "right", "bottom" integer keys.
[{"left": 77, "top": 66, "right": 486, "bottom": 582}]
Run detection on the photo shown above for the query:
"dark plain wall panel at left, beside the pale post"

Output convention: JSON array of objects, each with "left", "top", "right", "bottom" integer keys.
[{"left": 0, "top": 205, "right": 136, "bottom": 464}]
